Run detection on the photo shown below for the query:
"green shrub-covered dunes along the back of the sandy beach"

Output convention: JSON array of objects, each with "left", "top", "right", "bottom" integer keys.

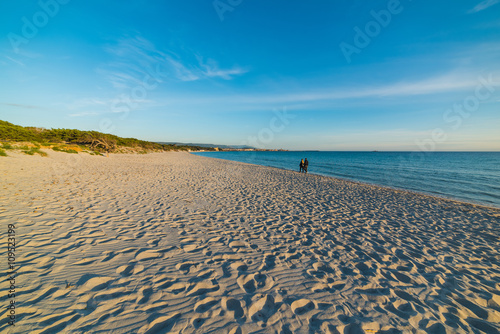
[{"left": 0, "top": 120, "right": 213, "bottom": 154}]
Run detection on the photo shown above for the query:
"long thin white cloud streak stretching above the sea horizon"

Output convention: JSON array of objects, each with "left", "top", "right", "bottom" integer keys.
[{"left": 154, "top": 72, "right": 498, "bottom": 111}]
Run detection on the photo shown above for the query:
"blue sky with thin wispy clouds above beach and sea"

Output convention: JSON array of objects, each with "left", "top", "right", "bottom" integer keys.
[{"left": 0, "top": 0, "right": 500, "bottom": 151}]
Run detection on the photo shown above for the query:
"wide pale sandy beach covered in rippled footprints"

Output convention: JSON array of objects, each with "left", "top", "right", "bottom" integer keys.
[{"left": 0, "top": 151, "right": 500, "bottom": 334}]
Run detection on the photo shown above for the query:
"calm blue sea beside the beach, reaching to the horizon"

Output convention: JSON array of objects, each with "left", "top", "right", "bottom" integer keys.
[{"left": 196, "top": 152, "right": 500, "bottom": 208}]
